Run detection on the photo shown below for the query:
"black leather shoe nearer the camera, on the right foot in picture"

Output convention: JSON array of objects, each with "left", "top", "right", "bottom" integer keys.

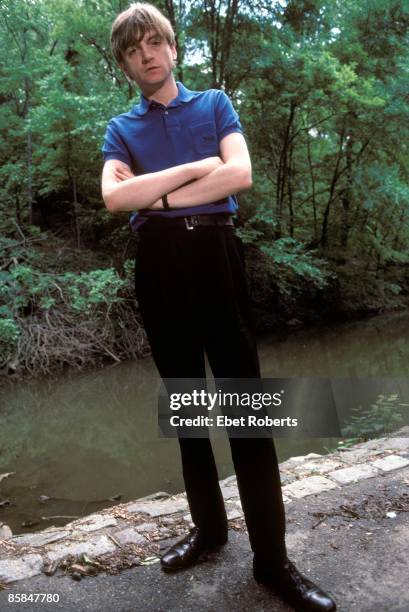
[{"left": 253, "top": 559, "right": 337, "bottom": 612}]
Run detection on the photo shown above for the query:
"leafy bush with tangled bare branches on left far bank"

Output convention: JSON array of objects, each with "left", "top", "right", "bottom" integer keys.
[{"left": 0, "top": 235, "right": 146, "bottom": 374}]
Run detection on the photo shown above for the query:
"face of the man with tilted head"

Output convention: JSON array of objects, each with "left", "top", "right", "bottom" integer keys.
[{"left": 121, "top": 31, "right": 176, "bottom": 93}]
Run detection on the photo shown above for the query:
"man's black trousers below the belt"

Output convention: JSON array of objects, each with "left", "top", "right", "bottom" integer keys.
[{"left": 135, "top": 218, "right": 286, "bottom": 562}]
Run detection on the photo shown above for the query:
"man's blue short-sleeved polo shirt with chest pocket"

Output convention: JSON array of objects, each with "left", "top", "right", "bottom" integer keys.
[{"left": 102, "top": 82, "right": 242, "bottom": 229}]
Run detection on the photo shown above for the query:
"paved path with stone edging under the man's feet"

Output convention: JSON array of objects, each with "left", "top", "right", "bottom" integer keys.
[{"left": 0, "top": 432, "right": 409, "bottom": 612}]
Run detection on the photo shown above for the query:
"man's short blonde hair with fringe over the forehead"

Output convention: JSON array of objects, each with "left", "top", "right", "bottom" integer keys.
[{"left": 111, "top": 2, "right": 175, "bottom": 64}]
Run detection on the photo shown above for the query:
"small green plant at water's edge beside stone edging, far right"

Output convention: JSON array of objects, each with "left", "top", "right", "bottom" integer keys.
[{"left": 340, "top": 394, "right": 408, "bottom": 446}]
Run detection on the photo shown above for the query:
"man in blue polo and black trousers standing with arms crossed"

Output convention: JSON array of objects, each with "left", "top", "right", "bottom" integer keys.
[{"left": 102, "top": 3, "right": 335, "bottom": 611}]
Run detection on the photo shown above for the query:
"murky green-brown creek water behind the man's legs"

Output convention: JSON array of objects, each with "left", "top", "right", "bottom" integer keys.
[{"left": 0, "top": 313, "right": 409, "bottom": 532}]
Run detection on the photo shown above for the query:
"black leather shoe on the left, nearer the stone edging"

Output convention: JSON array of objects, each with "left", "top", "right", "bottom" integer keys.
[{"left": 161, "top": 527, "right": 227, "bottom": 572}]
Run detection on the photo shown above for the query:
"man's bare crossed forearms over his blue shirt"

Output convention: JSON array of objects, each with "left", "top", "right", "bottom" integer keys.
[{"left": 102, "top": 132, "right": 252, "bottom": 213}]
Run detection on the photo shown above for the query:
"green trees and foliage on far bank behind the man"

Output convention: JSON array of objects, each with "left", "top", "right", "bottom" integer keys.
[{"left": 0, "top": 0, "right": 409, "bottom": 372}]
